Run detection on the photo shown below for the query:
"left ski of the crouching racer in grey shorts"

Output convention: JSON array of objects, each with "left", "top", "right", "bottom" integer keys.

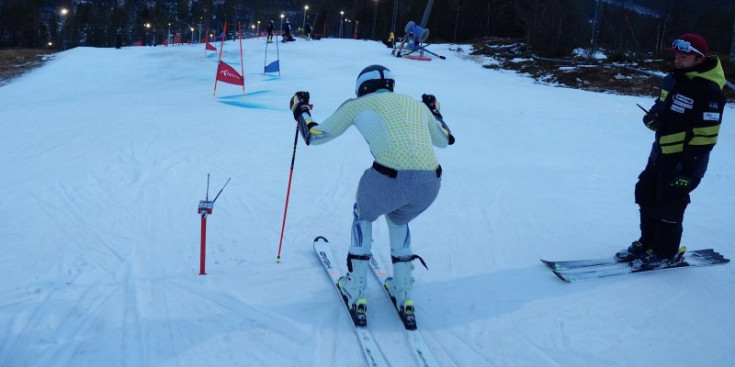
[{"left": 313, "top": 236, "right": 388, "bottom": 367}]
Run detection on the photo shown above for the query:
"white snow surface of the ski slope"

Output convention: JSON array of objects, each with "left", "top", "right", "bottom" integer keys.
[{"left": 0, "top": 39, "right": 735, "bottom": 367}]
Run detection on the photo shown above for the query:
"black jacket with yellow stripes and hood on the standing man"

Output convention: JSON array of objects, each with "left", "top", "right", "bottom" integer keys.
[{"left": 649, "top": 56, "right": 727, "bottom": 178}]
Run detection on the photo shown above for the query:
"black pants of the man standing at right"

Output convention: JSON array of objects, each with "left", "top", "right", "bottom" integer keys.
[{"left": 635, "top": 164, "right": 700, "bottom": 257}]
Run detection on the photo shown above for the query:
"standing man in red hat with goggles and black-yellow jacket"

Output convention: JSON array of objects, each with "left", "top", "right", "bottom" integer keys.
[{"left": 615, "top": 33, "right": 726, "bottom": 269}]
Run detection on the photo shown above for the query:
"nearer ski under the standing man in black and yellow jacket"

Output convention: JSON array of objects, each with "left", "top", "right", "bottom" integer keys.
[{"left": 553, "top": 249, "right": 730, "bottom": 283}]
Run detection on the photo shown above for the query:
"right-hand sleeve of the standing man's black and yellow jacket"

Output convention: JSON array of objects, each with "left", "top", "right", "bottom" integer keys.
[{"left": 680, "top": 88, "right": 725, "bottom": 178}]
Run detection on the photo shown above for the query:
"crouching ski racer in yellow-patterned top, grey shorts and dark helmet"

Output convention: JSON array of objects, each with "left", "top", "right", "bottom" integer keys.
[{"left": 290, "top": 65, "right": 454, "bottom": 317}]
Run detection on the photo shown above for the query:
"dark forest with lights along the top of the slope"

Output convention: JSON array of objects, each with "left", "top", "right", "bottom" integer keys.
[{"left": 0, "top": 0, "right": 735, "bottom": 56}]
